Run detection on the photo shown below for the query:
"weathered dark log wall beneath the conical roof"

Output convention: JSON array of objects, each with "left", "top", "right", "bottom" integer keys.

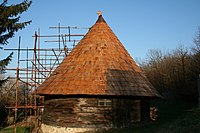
[{"left": 42, "top": 98, "right": 144, "bottom": 129}]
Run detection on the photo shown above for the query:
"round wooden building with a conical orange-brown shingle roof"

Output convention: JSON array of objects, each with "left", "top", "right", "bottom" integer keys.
[{"left": 38, "top": 14, "right": 160, "bottom": 132}]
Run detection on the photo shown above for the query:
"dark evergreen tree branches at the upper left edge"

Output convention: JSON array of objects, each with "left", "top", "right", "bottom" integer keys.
[{"left": 0, "top": 0, "right": 32, "bottom": 88}]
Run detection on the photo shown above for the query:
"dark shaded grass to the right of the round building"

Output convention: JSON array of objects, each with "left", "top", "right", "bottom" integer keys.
[{"left": 108, "top": 100, "right": 200, "bottom": 133}]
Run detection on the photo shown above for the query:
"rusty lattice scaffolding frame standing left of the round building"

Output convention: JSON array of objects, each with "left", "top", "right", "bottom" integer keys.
[{"left": 0, "top": 23, "right": 89, "bottom": 133}]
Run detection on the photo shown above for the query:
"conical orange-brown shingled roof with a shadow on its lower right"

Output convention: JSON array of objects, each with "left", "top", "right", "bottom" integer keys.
[{"left": 38, "top": 15, "right": 159, "bottom": 97}]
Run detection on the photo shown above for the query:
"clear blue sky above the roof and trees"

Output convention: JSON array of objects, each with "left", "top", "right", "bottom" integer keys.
[{"left": 0, "top": 0, "right": 200, "bottom": 68}]
